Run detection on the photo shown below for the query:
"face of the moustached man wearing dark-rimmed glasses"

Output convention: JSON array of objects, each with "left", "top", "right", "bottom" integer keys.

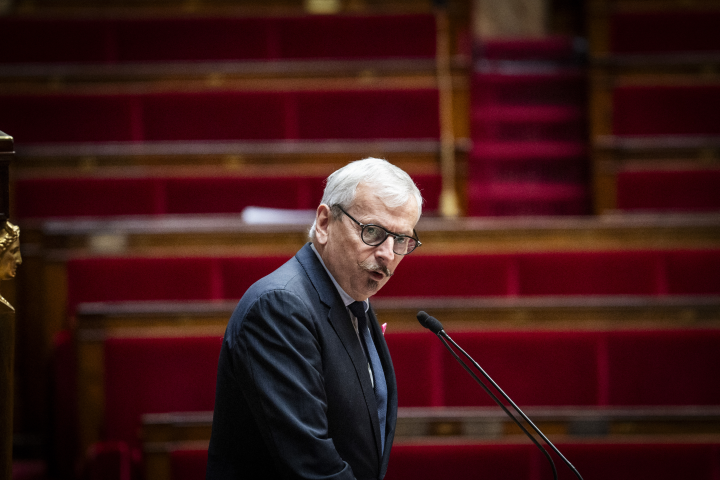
[{"left": 316, "top": 183, "right": 418, "bottom": 300}]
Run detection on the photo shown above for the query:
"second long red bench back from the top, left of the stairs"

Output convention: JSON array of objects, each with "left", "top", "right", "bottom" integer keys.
[{"left": 0, "top": 89, "right": 440, "bottom": 145}]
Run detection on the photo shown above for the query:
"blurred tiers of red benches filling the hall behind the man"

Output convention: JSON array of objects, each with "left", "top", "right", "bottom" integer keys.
[{"left": 0, "top": 0, "right": 720, "bottom": 480}]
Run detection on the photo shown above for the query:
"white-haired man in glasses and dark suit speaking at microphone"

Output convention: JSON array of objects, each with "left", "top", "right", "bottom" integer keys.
[{"left": 207, "top": 158, "right": 422, "bottom": 480}]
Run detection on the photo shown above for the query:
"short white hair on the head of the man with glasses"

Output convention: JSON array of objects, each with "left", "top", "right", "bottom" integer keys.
[{"left": 310, "top": 157, "right": 423, "bottom": 239}]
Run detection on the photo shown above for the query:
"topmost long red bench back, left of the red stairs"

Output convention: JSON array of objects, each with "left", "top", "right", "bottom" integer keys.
[{"left": 0, "top": 14, "right": 436, "bottom": 65}]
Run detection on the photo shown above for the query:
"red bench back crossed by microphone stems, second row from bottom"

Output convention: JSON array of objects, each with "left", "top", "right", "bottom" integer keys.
[{"left": 428, "top": 329, "right": 720, "bottom": 407}]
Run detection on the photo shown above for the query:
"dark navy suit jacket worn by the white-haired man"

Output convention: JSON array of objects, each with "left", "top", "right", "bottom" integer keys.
[{"left": 207, "top": 244, "right": 397, "bottom": 480}]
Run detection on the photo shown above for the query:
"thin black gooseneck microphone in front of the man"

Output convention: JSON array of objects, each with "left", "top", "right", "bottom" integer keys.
[{"left": 417, "top": 311, "right": 583, "bottom": 480}]
